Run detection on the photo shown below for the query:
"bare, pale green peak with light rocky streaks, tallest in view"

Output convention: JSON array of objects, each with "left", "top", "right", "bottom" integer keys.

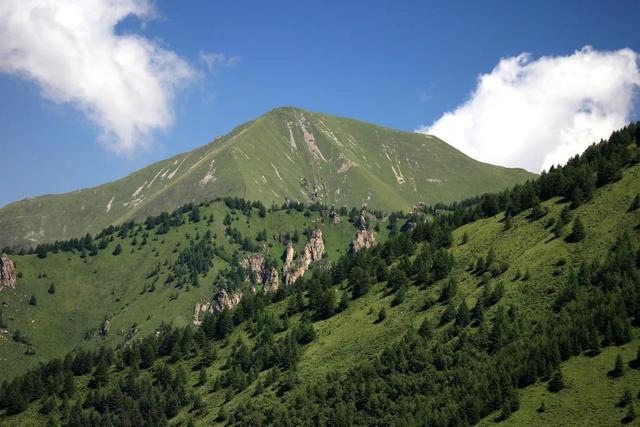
[{"left": 0, "top": 108, "right": 535, "bottom": 247}]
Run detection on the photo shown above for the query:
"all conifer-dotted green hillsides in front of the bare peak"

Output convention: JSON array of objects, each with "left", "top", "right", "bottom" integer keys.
[{"left": 0, "top": 124, "right": 640, "bottom": 426}]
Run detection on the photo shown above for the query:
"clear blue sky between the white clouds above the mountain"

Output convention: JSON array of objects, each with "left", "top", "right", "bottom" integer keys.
[{"left": 0, "top": 1, "right": 640, "bottom": 206}]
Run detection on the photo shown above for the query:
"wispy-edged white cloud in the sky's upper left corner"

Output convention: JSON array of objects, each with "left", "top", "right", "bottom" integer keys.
[{"left": 0, "top": 0, "right": 196, "bottom": 154}]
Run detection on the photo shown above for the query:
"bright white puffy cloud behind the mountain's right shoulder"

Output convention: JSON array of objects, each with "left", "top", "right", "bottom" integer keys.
[{"left": 417, "top": 47, "right": 640, "bottom": 171}]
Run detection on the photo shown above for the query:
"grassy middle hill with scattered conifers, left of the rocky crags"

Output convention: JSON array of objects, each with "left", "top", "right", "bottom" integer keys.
[{"left": 0, "top": 201, "right": 376, "bottom": 380}]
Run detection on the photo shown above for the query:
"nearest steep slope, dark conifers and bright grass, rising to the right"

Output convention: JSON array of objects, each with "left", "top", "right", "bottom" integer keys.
[{"left": 0, "top": 124, "right": 640, "bottom": 426}]
